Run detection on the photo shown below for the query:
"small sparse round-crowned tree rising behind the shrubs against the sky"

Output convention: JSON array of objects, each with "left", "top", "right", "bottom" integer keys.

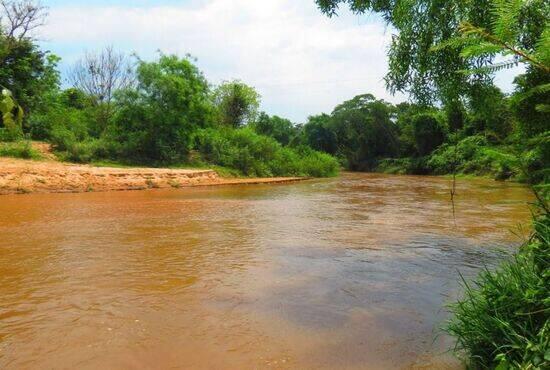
[{"left": 213, "top": 80, "right": 261, "bottom": 127}]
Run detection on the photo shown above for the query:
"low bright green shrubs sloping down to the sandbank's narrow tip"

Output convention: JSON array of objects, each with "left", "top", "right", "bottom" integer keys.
[{"left": 194, "top": 128, "right": 338, "bottom": 177}]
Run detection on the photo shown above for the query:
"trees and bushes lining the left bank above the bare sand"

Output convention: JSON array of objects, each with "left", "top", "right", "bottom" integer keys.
[{"left": 0, "top": 2, "right": 339, "bottom": 177}]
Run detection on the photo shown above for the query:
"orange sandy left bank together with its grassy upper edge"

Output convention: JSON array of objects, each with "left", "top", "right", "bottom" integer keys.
[{"left": 0, "top": 141, "right": 309, "bottom": 195}]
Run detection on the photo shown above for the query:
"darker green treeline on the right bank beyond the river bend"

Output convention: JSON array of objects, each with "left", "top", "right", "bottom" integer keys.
[{"left": 302, "top": 87, "right": 550, "bottom": 182}]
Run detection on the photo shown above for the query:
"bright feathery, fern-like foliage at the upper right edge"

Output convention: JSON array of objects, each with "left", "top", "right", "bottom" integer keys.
[{"left": 435, "top": 0, "right": 550, "bottom": 136}]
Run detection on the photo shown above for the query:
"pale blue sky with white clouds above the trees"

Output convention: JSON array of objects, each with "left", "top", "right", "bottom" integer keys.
[{"left": 39, "top": 0, "right": 520, "bottom": 122}]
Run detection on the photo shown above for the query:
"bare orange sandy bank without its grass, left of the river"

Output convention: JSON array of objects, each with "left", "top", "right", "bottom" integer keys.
[{"left": 0, "top": 158, "right": 304, "bottom": 195}]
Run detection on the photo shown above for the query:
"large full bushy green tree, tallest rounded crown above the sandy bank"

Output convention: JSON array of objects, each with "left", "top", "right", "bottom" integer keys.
[{"left": 107, "top": 54, "right": 216, "bottom": 163}]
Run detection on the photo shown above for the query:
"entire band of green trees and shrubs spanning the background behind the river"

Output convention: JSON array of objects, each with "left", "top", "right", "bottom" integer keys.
[{"left": 0, "top": 1, "right": 550, "bottom": 183}]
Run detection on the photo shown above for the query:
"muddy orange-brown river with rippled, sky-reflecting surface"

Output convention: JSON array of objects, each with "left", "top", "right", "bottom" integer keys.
[{"left": 0, "top": 174, "right": 531, "bottom": 369}]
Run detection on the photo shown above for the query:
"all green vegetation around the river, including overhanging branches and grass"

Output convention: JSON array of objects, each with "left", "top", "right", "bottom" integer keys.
[{"left": 0, "top": 0, "right": 550, "bottom": 369}]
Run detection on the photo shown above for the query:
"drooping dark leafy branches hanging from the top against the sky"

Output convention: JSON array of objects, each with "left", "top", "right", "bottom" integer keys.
[{"left": 316, "top": 0, "right": 550, "bottom": 105}]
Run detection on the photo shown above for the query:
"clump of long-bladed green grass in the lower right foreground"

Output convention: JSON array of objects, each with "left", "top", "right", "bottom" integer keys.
[{"left": 447, "top": 213, "right": 550, "bottom": 369}]
